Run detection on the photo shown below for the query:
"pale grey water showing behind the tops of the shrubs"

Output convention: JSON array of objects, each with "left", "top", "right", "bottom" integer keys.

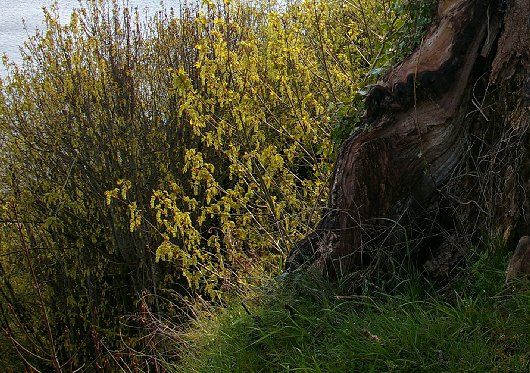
[{"left": 0, "top": 0, "right": 168, "bottom": 76}]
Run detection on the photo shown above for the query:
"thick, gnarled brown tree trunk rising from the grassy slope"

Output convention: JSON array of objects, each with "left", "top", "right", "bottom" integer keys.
[{"left": 287, "top": 0, "right": 530, "bottom": 277}]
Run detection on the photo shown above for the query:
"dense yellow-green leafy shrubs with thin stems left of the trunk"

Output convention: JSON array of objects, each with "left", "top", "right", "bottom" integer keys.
[{"left": 0, "top": 0, "right": 436, "bottom": 370}]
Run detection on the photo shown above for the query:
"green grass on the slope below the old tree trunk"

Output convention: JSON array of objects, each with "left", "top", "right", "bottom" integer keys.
[{"left": 172, "top": 247, "right": 530, "bottom": 372}]
